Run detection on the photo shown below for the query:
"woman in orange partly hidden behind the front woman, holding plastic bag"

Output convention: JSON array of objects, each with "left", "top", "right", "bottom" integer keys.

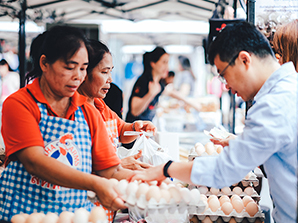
[{"left": 78, "top": 40, "right": 156, "bottom": 222}]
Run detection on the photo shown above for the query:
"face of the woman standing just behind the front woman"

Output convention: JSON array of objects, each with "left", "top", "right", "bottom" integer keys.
[{"left": 84, "top": 53, "right": 114, "bottom": 98}]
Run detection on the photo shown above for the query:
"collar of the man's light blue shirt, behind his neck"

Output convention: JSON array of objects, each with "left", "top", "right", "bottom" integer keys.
[{"left": 254, "top": 62, "right": 296, "bottom": 101}]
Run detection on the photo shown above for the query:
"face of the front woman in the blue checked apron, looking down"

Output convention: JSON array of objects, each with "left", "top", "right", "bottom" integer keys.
[{"left": 40, "top": 46, "right": 88, "bottom": 98}]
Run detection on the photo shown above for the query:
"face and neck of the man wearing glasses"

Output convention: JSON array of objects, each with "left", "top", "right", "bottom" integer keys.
[{"left": 214, "top": 53, "right": 256, "bottom": 101}]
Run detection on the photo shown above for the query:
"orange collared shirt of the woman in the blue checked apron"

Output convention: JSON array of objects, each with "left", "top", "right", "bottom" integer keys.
[{"left": 1, "top": 78, "right": 120, "bottom": 171}]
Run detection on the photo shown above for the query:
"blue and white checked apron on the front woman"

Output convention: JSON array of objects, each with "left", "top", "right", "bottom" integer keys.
[{"left": 0, "top": 103, "right": 94, "bottom": 220}]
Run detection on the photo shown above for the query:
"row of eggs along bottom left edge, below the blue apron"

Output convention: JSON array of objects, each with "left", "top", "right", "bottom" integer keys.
[{"left": 11, "top": 207, "right": 108, "bottom": 223}]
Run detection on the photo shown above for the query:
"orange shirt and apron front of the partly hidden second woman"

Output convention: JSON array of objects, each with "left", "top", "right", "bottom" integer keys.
[{"left": 94, "top": 98, "right": 125, "bottom": 149}]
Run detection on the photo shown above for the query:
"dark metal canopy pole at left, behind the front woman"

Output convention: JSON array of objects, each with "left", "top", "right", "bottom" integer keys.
[{"left": 19, "top": 0, "right": 27, "bottom": 87}]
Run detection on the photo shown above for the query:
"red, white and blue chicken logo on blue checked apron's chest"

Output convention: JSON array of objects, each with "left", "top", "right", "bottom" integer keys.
[{"left": 45, "top": 133, "right": 81, "bottom": 168}]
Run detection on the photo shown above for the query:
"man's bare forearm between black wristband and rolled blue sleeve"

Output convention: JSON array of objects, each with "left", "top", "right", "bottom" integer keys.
[{"left": 168, "top": 162, "right": 193, "bottom": 183}]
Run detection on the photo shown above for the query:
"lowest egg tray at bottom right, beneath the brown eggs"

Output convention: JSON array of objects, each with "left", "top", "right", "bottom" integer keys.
[{"left": 194, "top": 206, "right": 265, "bottom": 222}]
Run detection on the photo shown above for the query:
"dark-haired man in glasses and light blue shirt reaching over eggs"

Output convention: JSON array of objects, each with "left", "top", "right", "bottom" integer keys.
[{"left": 130, "top": 22, "right": 298, "bottom": 223}]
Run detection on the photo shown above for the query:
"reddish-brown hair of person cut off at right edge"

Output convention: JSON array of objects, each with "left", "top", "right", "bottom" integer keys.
[{"left": 273, "top": 19, "right": 298, "bottom": 72}]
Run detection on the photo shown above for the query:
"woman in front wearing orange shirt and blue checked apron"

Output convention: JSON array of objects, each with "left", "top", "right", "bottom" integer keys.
[{"left": 0, "top": 26, "right": 133, "bottom": 221}]
